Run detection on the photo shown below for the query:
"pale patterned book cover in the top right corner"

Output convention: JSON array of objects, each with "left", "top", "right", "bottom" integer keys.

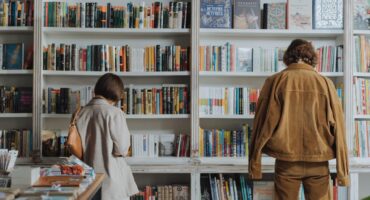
[{"left": 353, "top": 0, "right": 370, "bottom": 30}]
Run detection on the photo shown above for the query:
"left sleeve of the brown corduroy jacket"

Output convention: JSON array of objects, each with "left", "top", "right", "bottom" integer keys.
[{"left": 248, "top": 79, "right": 280, "bottom": 179}]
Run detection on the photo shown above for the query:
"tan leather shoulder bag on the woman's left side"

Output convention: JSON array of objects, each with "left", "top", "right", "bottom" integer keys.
[{"left": 67, "top": 107, "right": 83, "bottom": 160}]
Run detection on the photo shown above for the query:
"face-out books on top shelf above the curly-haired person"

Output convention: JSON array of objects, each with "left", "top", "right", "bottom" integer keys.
[{"left": 200, "top": 0, "right": 343, "bottom": 30}]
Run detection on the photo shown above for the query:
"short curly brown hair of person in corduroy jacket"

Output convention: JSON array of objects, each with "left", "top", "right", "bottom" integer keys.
[{"left": 283, "top": 39, "right": 317, "bottom": 67}]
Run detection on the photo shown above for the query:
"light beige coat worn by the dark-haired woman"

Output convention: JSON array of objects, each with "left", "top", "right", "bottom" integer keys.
[{"left": 77, "top": 99, "right": 138, "bottom": 200}]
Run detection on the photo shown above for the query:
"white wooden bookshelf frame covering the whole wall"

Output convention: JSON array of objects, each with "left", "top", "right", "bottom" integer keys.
[{"left": 0, "top": 0, "right": 370, "bottom": 200}]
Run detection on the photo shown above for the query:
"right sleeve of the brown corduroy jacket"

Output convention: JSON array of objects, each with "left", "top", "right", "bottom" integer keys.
[{"left": 326, "top": 80, "right": 349, "bottom": 186}]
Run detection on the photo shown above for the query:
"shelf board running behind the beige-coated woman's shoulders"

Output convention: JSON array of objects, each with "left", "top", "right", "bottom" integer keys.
[{"left": 42, "top": 114, "right": 190, "bottom": 119}]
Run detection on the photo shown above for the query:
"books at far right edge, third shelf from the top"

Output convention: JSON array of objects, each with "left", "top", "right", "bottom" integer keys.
[{"left": 353, "top": 77, "right": 370, "bottom": 115}]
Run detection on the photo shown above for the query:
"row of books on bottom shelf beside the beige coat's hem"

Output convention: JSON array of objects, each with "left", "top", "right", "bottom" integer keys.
[{"left": 130, "top": 185, "right": 190, "bottom": 200}]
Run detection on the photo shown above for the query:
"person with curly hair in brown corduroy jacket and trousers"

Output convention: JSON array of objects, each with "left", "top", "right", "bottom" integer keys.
[{"left": 249, "top": 39, "right": 349, "bottom": 200}]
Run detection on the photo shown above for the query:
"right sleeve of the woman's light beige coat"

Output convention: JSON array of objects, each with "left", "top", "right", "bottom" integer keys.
[{"left": 110, "top": 112, "right": 130, "bottom": 156}]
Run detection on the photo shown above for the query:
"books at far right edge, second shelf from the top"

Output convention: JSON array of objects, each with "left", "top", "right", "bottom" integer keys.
[{"left": 353, "top": 35, "right": 370, "bottom": 72}]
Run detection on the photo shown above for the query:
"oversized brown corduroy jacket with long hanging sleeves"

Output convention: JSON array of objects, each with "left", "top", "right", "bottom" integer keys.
[{"left": 249, "top": 63, "right": 349, "bottom": 186}]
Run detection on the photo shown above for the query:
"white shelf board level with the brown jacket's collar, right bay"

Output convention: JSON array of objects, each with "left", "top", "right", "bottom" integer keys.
[{"left": 199, "top": 71, "right": 344, "bottom": 77}]
